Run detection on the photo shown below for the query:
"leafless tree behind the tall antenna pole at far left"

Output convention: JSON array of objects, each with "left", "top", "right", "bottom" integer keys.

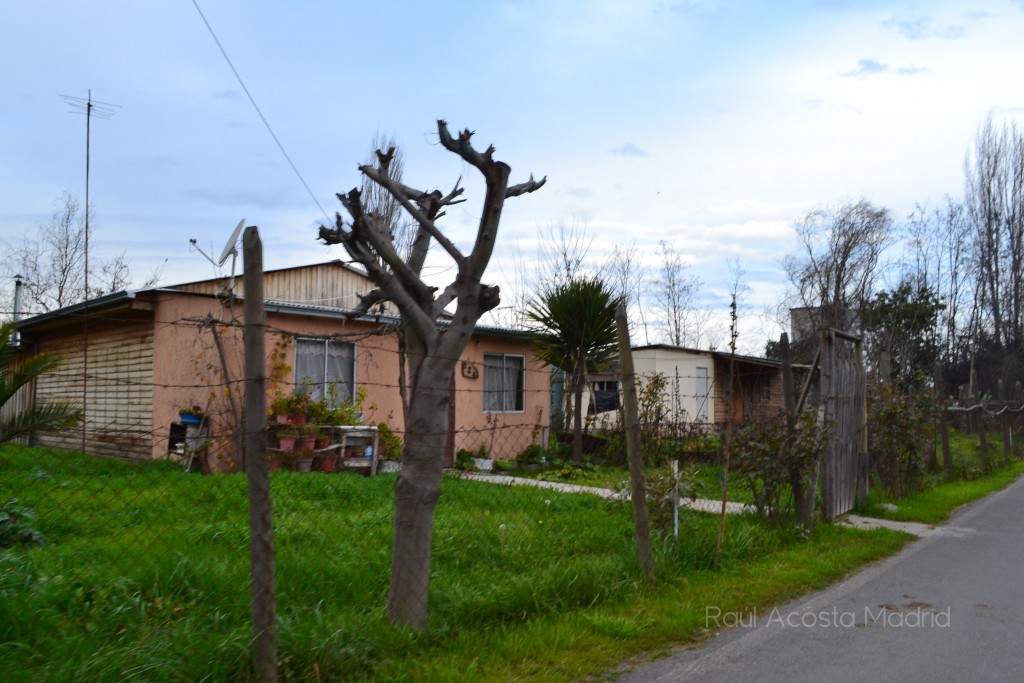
[{"left": 4, "top": 191, "right": 160, "bottom": 313}]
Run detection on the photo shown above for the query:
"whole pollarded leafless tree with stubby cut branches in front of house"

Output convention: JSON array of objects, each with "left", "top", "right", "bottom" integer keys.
[{"left": 319, "top": 121, "right": 546, "bottom": 630}]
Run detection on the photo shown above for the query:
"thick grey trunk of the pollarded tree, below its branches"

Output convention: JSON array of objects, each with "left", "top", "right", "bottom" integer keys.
[{"left": 387, "top": 356, "right": 452, "bottom": 631}]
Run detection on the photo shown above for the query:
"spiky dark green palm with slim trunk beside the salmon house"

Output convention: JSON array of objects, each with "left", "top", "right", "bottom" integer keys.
[{"left": 526, "top": 278, "right": 618, "bottom": 460}]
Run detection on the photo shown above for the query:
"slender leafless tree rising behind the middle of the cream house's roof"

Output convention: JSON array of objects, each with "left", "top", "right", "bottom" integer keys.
[{"left": 649, "top": 240, "right": 711, "bottom": 347}]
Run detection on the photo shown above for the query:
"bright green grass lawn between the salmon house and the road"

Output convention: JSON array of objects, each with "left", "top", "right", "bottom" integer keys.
[{"left": 0, "top": 446, "right": 1015, "bottom": 681}]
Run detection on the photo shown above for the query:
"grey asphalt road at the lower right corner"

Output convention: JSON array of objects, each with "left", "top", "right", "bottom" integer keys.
[{"left": 620, "top": 479, "right": 1024, "bottom": 683}]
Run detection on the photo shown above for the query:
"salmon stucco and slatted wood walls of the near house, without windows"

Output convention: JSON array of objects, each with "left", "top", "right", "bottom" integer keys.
[{"left": 18, "top": 280, "right": 550, "bottom": 471}]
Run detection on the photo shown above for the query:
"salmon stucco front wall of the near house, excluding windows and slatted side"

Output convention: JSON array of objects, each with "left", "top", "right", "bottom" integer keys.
[{"left": 153, "top": 293, "right": 550, "bottom": 469}]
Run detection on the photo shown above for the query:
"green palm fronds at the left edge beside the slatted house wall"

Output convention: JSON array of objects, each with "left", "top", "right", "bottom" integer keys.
[{"left": 0, "top": 323, "right": 82, "bottom": 443}]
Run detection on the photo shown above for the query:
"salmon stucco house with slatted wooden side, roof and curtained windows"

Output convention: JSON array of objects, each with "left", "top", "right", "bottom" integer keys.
[{"left": 12, "top": 261, "right": 550, "bottom": 469}]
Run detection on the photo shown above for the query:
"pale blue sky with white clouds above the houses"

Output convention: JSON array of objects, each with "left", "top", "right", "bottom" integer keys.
[{"left": 0, "top": 0, "right": 1024, "bottom": 349}]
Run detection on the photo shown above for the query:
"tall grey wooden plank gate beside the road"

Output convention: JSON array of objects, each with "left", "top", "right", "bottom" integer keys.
[{"left": 819, "top": 330, "right": 868, "bottom": 520}]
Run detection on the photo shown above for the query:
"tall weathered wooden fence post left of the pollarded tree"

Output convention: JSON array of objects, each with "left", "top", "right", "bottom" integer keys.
[{"left": 242, "top": 226, "right": 278, "bottom": 683}]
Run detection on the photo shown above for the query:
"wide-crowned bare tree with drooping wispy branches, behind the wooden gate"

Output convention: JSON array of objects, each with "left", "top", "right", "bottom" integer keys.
[{"left": 782, "top": 199, "right": 893, "bottom": 330}]
